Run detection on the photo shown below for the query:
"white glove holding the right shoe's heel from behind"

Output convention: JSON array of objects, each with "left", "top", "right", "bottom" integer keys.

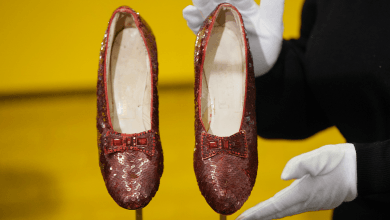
[{"left": 183, "top": 0, "right": 284, "bottom": 77}]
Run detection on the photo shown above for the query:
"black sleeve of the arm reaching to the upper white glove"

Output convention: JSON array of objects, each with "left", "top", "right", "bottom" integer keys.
[{"left": 256, "top": 0, "right": 332, "bottom": 139}]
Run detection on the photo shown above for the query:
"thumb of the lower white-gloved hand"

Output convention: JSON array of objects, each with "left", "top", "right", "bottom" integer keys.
[{"left": 282, "top": 145, "right": 344, "bottom": 180}]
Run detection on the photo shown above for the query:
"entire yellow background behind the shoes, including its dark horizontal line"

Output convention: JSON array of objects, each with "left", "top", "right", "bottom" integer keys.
[{"left": 0, "top": 0, "right": 345, "bottom": 220}]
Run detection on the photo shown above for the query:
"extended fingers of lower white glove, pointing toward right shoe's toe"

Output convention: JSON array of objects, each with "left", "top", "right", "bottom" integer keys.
[{"left": 238, "top": 176, "right": 309, "bottom": 219}]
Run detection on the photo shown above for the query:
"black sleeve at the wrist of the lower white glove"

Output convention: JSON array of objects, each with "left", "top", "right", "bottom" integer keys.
[{"left": 354, "top": 140, "right": 390, "bottom": 201}]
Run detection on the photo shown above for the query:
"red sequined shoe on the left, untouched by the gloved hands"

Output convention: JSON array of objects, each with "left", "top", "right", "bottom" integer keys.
[{"left": 97, "top": 6, "right": 163, "bottom": 209}]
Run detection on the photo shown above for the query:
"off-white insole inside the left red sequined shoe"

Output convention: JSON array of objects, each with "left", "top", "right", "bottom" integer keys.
[{"left": 109, "top": 27, "right": 151, "bottom": 134}]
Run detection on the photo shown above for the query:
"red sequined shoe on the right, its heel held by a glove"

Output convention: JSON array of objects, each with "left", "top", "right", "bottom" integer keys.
[{"left": 194, "top": 3, "right": 258, "bottom": 215}]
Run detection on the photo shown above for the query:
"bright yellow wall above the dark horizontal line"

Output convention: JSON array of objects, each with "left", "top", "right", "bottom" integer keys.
[{"left": 0, "top": 0, "right": 303, "bottom": 94}]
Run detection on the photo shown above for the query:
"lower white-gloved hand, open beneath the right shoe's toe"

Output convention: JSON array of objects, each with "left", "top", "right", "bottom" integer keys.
[{"left": 237, "top": 144, "right": 357, "bottom": 220}]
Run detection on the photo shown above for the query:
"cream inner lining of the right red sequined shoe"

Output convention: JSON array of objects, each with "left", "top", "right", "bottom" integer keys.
[{"left": 201, "top": 8, "right": 246, "bottom": 137}]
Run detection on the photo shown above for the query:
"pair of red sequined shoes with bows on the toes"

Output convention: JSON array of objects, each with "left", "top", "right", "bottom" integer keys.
[{"left": 97, "top": 3, "right": 257, "bottom": 215}]
